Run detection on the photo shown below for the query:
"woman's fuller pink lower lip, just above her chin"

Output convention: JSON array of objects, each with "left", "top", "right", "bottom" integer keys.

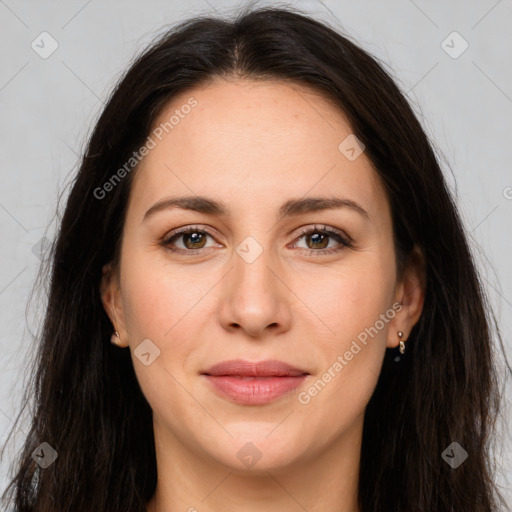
[{"left": 206, "top": 375, "right": 307, "bottom": 405}]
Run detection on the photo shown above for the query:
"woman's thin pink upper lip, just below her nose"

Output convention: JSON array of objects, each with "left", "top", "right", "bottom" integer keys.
[{"left": 202, "top": 359, "right": 309, "bottom": 377}]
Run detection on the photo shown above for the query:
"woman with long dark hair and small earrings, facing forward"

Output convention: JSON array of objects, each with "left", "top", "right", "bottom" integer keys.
[{"left": 0, "top": 4, "right": 506, "bottom": 512}]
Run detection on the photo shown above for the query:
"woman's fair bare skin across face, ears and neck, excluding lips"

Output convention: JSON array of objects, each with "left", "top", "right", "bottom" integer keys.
[{"left": 102, "top": 80, "right": 424, "bottom": 512}]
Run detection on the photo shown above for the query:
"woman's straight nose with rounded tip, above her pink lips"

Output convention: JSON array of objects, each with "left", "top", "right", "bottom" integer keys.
[{"left": 220, "top": 250, "right": 293, "bottom": 338}]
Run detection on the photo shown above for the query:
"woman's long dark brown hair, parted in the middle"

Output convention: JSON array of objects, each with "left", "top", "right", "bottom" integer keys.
[{"left": 1, "top": 8, "right": 508, "bottom": 512}]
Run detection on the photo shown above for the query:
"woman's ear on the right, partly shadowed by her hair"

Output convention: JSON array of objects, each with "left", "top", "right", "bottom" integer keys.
[{"left": 386, "top": 246, "right": 426, "bottom": 348}]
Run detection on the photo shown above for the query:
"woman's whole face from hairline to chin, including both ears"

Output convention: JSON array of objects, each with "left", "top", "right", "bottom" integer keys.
[{"left": 104, "top": 80, "right": 419, "bottom": 471}]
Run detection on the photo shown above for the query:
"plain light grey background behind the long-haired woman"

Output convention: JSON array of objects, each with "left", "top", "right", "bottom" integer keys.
[{"left": 0, "top": 0, "right": 512, "bottom": 502}]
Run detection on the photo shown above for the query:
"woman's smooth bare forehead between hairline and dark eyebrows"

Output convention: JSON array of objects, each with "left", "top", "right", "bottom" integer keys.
[{"left": 127, "top": 80, "right": 386, "bottom": 222}]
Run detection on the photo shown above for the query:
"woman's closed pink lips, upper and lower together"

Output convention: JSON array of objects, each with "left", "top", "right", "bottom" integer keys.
[{"left": 202, "top": 359, "right": 309, "bottom": 405}]
